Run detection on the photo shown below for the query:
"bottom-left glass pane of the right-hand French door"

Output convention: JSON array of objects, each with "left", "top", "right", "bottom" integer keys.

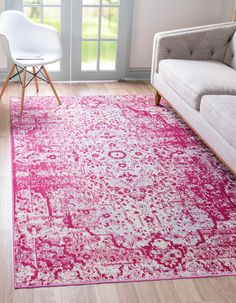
[{"left": 81, "top": 41, "right": 98, "bottom": 71}]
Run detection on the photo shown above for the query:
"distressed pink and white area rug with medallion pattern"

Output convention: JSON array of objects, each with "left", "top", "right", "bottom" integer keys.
[{"left": 11, "top": 96, "right": 236, "bottom": 288}]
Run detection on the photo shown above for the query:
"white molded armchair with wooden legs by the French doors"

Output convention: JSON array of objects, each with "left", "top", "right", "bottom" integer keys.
[{"left": 0, "top": 10, "right": 62, "bottom": 113}]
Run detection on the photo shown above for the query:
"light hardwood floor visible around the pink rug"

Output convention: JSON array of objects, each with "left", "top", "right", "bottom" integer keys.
[{"left": 0, "top": 82, "right": 236, "bottom": 303}]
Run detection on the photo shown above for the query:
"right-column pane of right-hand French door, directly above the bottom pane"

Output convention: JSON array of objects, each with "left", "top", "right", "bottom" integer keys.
[{"left": 101, "top": 7, "right": 118, "bottom": 39}]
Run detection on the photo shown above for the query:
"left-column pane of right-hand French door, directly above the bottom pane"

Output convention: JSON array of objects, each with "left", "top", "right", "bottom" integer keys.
[{"left": 82, "top": 7, "right": 99, "bottom": 38}]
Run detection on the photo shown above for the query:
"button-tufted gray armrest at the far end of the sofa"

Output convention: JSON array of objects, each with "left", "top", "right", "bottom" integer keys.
[{"left": 151, "top": 22, "right": 236, "bottom": 84}]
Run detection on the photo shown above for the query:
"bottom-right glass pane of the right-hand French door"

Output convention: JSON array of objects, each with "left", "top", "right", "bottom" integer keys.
[{"left": 100, "top": 41, "right": 117, "bottom": 70}]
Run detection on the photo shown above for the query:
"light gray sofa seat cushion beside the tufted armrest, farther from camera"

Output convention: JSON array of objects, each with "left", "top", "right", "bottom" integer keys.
[{"left": 159, "top": 59, "right": 236, "bottom": 110}]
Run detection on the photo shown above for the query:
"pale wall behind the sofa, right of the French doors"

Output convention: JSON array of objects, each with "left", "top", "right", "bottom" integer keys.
[{"left": 130, "top": 0, "right": 234, "bottom": 68}]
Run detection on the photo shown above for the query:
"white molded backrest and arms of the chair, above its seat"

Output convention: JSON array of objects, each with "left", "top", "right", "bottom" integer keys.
[{"left": 0, "top": 10, "right": 61, "bottom": 59}]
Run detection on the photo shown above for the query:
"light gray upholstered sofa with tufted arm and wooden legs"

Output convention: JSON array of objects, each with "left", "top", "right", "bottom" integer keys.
[{"left": 151, "top": 22, "right": 236, "bottom": 174}]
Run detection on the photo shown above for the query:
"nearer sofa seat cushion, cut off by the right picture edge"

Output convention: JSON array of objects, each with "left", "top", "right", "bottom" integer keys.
[{"left": 200, "top": 96, "right": 236, "bottom": 150}]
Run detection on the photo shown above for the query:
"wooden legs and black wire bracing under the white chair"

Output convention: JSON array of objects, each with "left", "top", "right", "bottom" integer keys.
[{"left": 0, "top": 64, "right": 61, "bottom": 113}]
